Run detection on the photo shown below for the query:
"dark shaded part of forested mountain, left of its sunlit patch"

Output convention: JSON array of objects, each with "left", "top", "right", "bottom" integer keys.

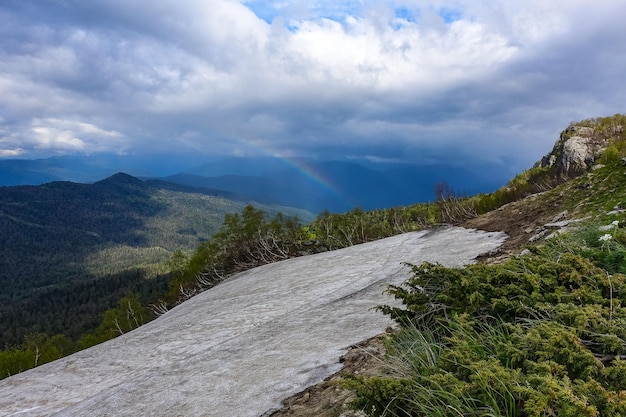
[{"left": 0, "top": 174, "right": 167, "bottom": 345}]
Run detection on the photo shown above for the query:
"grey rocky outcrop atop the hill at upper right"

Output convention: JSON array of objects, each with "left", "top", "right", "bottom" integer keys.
[{"left": 541, "top": 125, "right": 610, "bottom": 177}]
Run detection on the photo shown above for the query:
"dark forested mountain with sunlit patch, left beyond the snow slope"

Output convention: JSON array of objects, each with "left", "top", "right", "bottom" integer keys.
[{"left": 0, "top": 174, "right": 311, "bottom": 346}]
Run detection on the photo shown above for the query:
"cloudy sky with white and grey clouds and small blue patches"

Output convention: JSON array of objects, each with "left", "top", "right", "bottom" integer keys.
[{"left": 0, "top": 0, "right": 626, "bottom": 170}]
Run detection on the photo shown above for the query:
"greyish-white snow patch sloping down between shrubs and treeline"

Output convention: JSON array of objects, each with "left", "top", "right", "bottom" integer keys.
[{"left": 0, "top": 227, "right": 506, "bottom": 417}]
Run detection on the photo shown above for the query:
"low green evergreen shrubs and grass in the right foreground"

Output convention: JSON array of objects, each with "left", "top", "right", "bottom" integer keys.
[{"left": 347, "top": 252, "right": 626, "bottom": 417}]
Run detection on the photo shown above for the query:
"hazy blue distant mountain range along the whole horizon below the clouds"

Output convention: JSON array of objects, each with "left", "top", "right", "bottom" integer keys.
[{"left": 0, "top": 155, "right": 508, "bottom": 213}]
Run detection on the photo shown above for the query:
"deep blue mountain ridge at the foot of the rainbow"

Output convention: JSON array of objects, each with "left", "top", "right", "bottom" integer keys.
[{"left": 163, "top": 159, "right": 502, "bottom": 213}]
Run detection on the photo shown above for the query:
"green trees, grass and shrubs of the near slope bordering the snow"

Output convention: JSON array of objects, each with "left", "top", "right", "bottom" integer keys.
[{"left": 0, "top": 111, "right": 626, "bottom": 416}]
